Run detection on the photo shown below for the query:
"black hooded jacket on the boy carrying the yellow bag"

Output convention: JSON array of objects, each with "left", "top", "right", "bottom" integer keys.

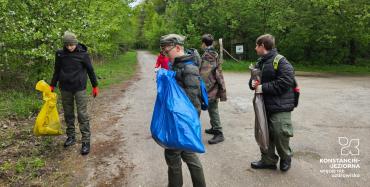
[{"left": 50, "top": 44, "right": 98, "bottom": 92}]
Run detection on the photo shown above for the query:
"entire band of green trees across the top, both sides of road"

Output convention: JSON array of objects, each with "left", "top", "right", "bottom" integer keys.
[{"left": 0, "top": 0, "right": 370, "bottom": 88}]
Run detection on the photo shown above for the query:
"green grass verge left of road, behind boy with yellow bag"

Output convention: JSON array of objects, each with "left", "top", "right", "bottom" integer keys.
[{"left": 0, "top": 51, "right": 136, "bottom": 120}]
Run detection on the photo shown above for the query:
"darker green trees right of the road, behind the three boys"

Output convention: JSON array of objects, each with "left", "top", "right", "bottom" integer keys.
[{"left": 135, "top": 0, "right": 370, "bottom": 65}]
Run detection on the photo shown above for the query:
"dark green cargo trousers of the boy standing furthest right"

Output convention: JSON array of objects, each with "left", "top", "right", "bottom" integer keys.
[{"left": 261, "top": 112, "right": 293, "bottom": 164}]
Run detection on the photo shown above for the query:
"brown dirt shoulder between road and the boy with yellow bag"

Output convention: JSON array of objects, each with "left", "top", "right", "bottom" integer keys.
[{"left": 42, "top": 65, "right": 139, "bottom": 186}]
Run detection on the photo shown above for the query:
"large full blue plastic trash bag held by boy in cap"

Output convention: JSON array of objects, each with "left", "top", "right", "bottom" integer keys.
[{"left": 150, "top": 69, "right": 205, "bottom": 153}]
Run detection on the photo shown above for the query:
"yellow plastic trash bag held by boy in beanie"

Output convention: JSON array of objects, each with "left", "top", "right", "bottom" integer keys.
[{"left": 33, "top": 80, "right": 63, "bottom": 136}]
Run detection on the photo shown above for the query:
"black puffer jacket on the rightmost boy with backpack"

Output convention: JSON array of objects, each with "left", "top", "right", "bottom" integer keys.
[{"left": 249, "top": 49, "right": 295, "bottom": 113}]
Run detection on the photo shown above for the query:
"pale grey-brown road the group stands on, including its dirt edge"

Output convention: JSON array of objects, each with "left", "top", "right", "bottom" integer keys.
[{"left": 62, "top": 51, "right": 370, "bottom": 187}]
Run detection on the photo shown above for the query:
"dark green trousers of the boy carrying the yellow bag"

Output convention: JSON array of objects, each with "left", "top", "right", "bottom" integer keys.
[{"left": 61, "top": 90, "right": 91, "bottom": 143}]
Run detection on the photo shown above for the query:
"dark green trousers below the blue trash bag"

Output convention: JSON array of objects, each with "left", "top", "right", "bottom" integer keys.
[{"left": 164, "top": 149, "right": 206, "bottom": 187}]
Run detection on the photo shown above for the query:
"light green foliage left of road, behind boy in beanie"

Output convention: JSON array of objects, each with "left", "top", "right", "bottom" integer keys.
[{"left": 0, "top": 0, "right": 137, "bottom": 89}]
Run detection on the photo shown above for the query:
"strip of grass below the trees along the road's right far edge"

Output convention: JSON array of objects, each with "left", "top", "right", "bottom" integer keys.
[{"left": 222, "top": 60, "right": 370, "bottom": 75}]
